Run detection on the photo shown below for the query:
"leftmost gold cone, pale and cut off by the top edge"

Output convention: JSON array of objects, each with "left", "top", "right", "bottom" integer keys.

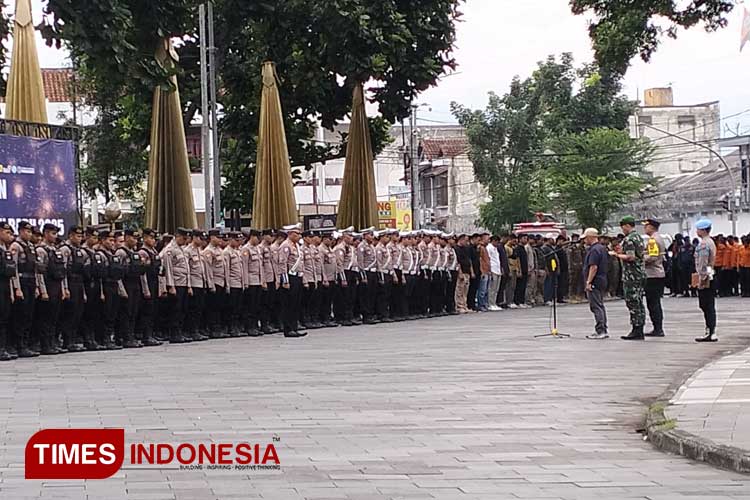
[{"left": 5, "top": 0, "right": 47, "bottom": 123}]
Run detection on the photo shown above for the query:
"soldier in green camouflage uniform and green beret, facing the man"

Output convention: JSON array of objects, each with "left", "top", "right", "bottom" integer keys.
[{"left": 616, "top": 217, "right": 646, "bottom": 340}]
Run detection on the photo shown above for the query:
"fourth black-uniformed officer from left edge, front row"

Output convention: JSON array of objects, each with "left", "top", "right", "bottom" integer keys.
[{"left": 60, "top": 226, "right": 91, "bottom": 352}]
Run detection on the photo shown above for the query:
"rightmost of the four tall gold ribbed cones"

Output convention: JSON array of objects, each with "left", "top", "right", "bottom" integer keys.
[{"left": 336, "top": 84, "right": 378, "bottom": 230}]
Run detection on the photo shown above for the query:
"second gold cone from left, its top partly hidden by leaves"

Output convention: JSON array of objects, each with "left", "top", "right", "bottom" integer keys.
[{"left": 146, "top": 39, "right": 198, "bottom": 234}]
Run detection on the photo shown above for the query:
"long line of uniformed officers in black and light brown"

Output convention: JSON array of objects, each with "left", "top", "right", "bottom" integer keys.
[{"left": 0, "top": 222, "right": 459, "bottom": 361}]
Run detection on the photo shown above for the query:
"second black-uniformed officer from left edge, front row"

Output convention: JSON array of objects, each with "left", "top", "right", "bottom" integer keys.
[{"left": 8, "top": 221, "right": 39, "bottom": 358}]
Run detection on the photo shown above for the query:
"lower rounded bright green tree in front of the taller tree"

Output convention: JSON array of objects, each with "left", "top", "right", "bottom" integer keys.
[{"left": 545, "top": 128, "right": 653, "bottom": 229}]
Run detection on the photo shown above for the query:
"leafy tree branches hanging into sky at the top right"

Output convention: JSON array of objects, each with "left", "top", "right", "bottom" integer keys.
[{"left": 570, "top": 0, "right": 736, "bottom": 75}]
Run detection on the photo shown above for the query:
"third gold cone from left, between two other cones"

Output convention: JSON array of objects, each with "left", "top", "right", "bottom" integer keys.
[{"left": 252, "top": 62, "right": 299, "bottom": 229}]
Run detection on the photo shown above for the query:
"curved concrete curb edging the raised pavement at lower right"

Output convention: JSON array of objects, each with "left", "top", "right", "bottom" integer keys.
[{"left": 646, "top": 400, "right": 750, "bottom": 474}]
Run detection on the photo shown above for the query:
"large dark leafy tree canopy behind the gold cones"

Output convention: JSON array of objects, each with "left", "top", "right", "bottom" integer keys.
[{"left": 43, "top": 0, "right": 468, "bottom": 213}]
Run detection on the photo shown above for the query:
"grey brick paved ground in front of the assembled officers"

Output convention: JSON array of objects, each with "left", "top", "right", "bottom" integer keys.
[{"left": 0, "top": 299, "right": 750, "bottom": 500}]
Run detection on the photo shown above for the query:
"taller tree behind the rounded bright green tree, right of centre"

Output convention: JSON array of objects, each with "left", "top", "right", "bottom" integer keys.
[{"left": 452, "top": 54, "right": 632, "bottom": 231}]
